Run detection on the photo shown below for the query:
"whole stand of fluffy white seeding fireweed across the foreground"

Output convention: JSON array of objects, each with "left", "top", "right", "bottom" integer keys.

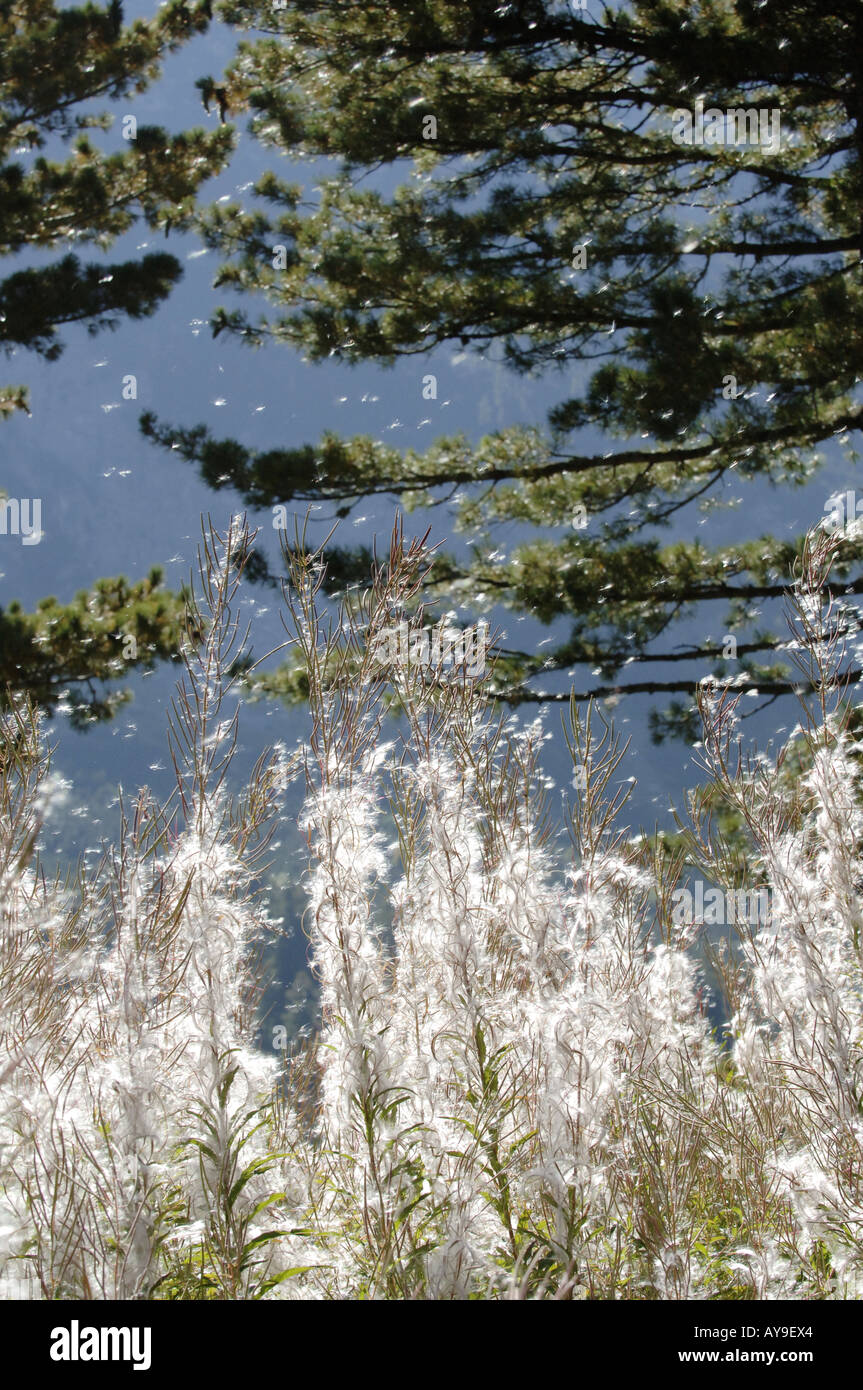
[{"left": 0, "top": 521, "right": 863, "bottom": 1300}]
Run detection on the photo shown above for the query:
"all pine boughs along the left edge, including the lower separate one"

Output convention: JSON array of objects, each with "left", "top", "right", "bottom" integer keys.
[{"left": 0, "top": 8, "right": 233, "bottom": 723}]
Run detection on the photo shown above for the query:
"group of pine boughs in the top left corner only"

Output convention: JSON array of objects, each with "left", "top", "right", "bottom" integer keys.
[{"left": 0, "top": 0, "right": 232, "bottom": 403}]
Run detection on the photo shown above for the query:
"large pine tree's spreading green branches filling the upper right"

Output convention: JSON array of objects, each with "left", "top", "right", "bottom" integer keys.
[{"left": 145, "top": 0, "right": 863, "bottom": 734}]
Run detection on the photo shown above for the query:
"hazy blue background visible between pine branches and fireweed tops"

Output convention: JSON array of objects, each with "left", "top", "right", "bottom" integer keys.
[{"left": 0, "top": 6, "right": 853, "bottom": 1034}]
